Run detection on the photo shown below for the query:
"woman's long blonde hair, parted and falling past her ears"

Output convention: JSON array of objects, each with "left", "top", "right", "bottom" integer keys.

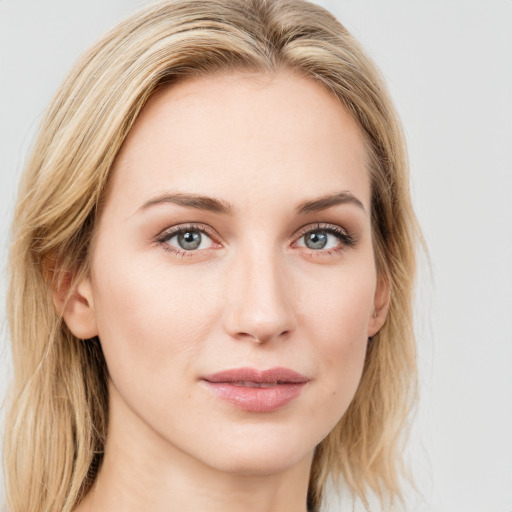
[{"left": 4, "top": 0, "right": 419, "bottom": 512}]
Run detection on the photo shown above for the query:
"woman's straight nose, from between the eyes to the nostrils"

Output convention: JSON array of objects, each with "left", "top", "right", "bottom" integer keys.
[{"left": 224, "top": 244, "right": 296, "bottom": 343}]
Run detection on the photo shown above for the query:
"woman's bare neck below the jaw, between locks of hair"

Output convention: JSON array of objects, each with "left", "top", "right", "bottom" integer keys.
[{"left": 76, "top": 382, "right": 312, "bottom": 512}]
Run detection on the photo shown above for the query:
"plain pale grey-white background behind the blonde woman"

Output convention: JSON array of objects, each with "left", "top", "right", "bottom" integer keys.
[{"left": 0, "top": 0, "right": 512, "bottom": 512}]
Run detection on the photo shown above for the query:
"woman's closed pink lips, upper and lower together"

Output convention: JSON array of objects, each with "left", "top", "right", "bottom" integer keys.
[{"left": 201, "top": 367, "right": 309, "bottom": 413}]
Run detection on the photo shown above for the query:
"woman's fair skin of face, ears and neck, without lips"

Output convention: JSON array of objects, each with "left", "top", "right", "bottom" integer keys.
[{"left": 64, "top": 72, "right": 387, "bottom": 512}]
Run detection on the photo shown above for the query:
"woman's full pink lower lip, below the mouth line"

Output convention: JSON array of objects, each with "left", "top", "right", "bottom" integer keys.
[{"left": 203, "top": 381, "right": 306, "bottom": 412}]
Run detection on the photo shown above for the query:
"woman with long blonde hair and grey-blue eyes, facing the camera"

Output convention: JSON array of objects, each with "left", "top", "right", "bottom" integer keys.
[{"left": 5, "top": 0, "right": 417, "bottom": 512}]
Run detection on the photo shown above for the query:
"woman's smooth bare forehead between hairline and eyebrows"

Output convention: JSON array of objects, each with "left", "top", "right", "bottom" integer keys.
[{"left": 109, "top": 72, "right": 370, "bottom": 210}]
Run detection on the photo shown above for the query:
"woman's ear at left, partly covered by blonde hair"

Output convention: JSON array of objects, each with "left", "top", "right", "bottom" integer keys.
[{"left": 52, "top": 275, "right": 98, "bottom": 340}]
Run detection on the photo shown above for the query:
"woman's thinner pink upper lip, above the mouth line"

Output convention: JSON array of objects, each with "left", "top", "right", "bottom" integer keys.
[{"left": 202, "top": 367, "right": 309, "bottom": 384}]
